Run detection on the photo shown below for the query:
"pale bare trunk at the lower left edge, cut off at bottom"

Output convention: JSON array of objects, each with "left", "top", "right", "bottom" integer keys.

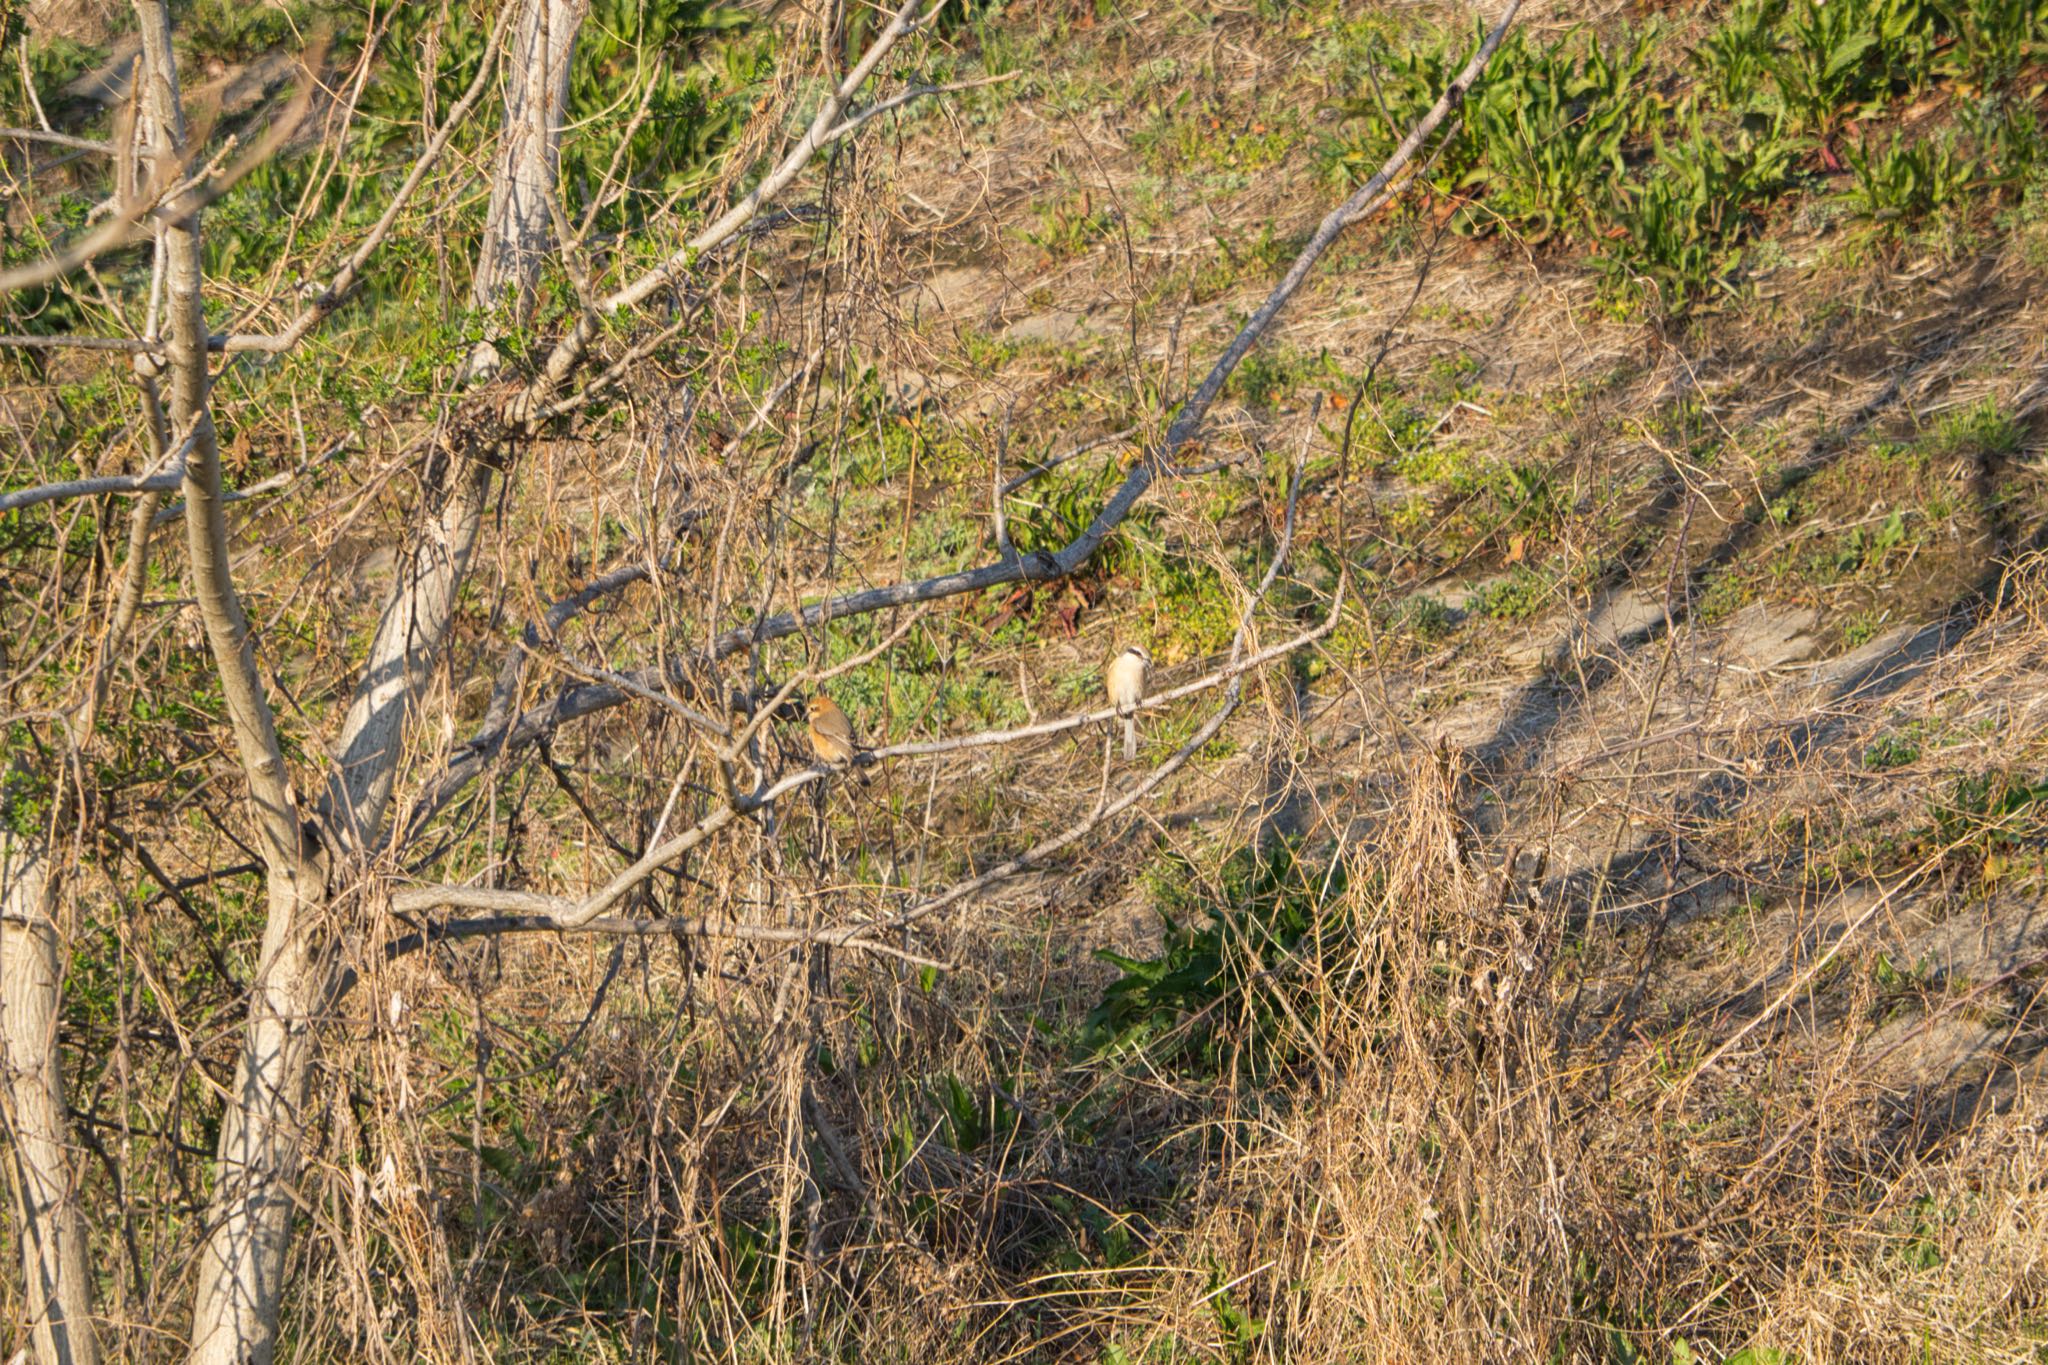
[{"left": 0, "top": 825, "right": 100, "bottom": 1365}]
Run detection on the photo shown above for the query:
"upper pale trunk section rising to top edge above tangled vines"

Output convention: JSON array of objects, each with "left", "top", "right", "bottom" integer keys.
[{"left": 469, "top": 0, "right": 590, "bottom": 375}]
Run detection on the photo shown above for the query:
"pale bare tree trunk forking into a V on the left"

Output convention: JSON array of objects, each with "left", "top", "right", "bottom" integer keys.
[{"left": 154, "top": 0, "right": 503, "bottom": 1342}]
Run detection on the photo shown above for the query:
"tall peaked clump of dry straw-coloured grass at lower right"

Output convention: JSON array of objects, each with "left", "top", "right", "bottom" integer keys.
[{"left": 1067, "top": 761, "right": 2048, "bottom": 1363}]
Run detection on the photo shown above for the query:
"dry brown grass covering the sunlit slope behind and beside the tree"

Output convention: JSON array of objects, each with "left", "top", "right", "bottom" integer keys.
[{"left": 12, "top": 0, "right": 2048, "bottom": 1365}]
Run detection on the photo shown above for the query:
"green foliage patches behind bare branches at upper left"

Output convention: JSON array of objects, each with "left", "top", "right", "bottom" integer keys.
[{"left": 0, "top": 0, "right": 774, "bottom": 362}]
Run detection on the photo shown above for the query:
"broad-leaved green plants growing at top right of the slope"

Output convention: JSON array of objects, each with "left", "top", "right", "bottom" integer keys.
[{"left": 1321, "top": 0, "right": 2048, "bottom": 313}]
